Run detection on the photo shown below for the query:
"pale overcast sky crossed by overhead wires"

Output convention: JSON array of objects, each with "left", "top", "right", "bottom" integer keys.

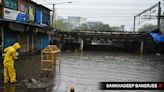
[{"left": 33, "top": 0, "right": 160, "bottom": 30}]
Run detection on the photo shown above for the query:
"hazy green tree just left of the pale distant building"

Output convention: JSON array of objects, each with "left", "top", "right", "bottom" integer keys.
[{"left": 54, "top": 19, "right": 72, "bottom": 31}]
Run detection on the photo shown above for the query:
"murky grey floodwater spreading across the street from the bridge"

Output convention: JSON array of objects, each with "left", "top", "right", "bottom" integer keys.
[{"left": 0, "top": 51, "right": 164, "bottom": 92}]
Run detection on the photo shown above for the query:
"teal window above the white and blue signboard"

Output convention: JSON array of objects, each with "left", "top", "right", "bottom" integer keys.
[{"left": 5, "top": 0, "right": 18, "bottom": 10}]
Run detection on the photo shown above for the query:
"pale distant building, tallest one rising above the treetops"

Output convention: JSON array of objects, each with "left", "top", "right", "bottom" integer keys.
[{"left": 68, "top": 16, "right": 87, "bottom": 29}]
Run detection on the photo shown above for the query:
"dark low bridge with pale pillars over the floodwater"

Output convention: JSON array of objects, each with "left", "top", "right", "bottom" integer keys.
[{"left": 52, "top": 31, "right": 149, "bottom": 53}]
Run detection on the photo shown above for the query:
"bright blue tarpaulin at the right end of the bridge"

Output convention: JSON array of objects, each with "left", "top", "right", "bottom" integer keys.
[{"left": 150, "top": 33, "right": 164, "bottom": 43}]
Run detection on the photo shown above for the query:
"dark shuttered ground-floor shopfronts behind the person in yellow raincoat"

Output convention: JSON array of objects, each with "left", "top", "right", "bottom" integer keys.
[{"left": 1, "top": 21, "right": 49, "bottom": 53}]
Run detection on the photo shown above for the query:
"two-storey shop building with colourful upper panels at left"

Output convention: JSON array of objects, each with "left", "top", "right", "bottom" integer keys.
[{"left": 0, "top": 0, "right": 53, "bottom": 53}]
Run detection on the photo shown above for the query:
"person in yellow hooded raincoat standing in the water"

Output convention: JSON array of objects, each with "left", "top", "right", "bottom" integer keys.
[{"left": 3, "top": 42, "right": 21, "bottom": 83}]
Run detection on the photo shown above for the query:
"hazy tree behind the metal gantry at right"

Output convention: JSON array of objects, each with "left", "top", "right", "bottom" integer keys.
[{"left": 138, "top": 24, "right": 158, "bottom": 32}]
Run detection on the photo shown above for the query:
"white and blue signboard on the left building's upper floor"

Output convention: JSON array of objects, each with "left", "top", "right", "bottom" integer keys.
[{"left": 4, "top": 8, "right": 26, "bottom": 22}]
